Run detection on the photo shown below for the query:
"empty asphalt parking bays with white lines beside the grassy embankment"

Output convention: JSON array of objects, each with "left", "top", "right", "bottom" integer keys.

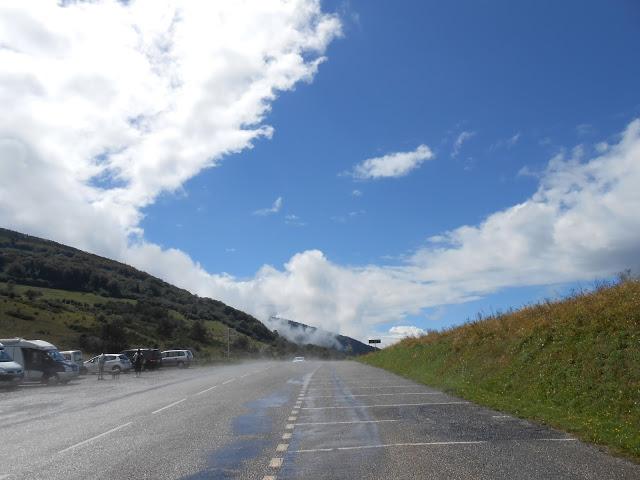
[{"left": 265, "top": 362, "right": 640, "bottom": 480}]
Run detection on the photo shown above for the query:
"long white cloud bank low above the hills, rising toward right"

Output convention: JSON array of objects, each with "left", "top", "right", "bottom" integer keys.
[{"left": 133, "top": 120, "right": 640, "bottom": 341}]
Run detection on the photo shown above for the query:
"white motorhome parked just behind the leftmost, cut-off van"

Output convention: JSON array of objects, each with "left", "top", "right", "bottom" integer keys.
[{"left": 0, "top": 338, "right": 79, "bottom": 383}]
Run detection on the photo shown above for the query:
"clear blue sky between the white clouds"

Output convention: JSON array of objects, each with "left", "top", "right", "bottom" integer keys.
[{"left": 142, "top": 1, "right": 640, "bottom": 336}]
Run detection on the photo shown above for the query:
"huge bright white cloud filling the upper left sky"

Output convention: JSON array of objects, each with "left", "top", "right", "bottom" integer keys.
[{"left": 0, "top": 0, "right": 340, "bottom": 253}]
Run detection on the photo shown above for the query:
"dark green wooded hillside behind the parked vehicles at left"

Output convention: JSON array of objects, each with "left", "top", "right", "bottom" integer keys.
[{"left": 0, "top": 229, "right": 342, "bottom": 358}]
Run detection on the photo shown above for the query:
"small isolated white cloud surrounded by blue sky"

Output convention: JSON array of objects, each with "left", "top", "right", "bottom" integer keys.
[{"left": 350, "top": 145, "right": 434, "bottom": 180}]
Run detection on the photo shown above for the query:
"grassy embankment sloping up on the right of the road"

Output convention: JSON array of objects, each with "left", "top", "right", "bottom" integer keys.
[{"left": 360, "top": 280, "right": 640, "bottom": 462}]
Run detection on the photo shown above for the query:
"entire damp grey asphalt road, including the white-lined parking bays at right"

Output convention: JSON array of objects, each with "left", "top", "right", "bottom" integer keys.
[{"left": 0, "top": 362, "right": 640, "bottom": 480}]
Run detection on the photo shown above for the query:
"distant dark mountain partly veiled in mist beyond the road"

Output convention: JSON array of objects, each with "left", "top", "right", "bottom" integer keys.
[{"left": 268, "top": 317, "right": 377, "bottom": 355}]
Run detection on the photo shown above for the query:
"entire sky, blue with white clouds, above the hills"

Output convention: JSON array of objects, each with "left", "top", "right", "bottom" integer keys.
[{"left": 0, "top": 0, "right": 640, "bottom": 345}]
